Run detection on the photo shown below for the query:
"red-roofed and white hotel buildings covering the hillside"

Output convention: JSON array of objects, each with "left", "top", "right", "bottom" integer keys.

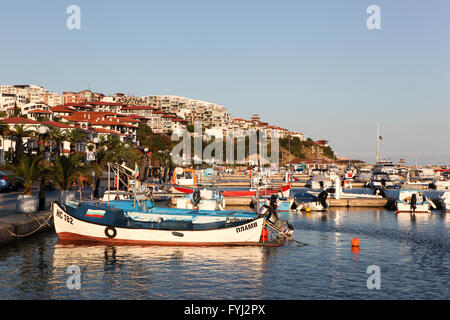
[{"left": 0, "top": 85, "right": 305, "bottom": 161}]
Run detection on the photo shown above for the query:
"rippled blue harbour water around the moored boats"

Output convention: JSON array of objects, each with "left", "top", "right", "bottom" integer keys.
[{"left": 0, "top": 189, "right": 450, "bottom": 300}]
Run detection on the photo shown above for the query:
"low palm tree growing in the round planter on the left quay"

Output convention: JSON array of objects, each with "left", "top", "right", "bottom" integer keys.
[{"left": 13, "top": 156, "right": 45, "bottom": 195}]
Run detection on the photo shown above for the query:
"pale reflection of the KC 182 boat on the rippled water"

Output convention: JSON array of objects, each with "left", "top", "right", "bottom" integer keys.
[{"left": 53, "top": 240, "right": 273, "bottom": 299}]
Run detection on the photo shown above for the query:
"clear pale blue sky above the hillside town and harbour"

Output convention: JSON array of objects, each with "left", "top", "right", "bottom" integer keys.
[{"left": 0, "top": 0, "right": 450, "bottom": 165}]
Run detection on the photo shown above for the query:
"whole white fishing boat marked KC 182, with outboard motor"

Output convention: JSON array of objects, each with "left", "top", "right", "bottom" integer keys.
[{"left": 53, "top": 203, "right": 293, "bottom": 246}]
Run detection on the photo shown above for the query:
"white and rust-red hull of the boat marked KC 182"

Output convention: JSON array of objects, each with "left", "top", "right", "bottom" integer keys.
[{"left": 53, "top": 203, "right": 264, "bottom": 246}]
